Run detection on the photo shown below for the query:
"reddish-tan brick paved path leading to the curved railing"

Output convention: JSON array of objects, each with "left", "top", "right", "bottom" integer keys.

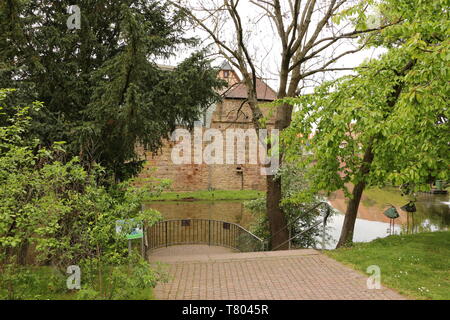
[{"left": 150, "top": 246, "right": 404, "bottom": 300}]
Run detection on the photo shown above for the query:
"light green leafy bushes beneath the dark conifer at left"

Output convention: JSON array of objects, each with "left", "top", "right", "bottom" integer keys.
[{"left": 0, "top": 90, "right": 165, "bottom": 298}]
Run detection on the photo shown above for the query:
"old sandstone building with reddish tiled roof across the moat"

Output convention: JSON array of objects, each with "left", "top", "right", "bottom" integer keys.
[{"left": 141, "top": 62, "right": 276, "bottom": 191}]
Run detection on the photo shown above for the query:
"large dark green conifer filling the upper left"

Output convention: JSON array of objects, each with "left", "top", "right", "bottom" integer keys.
[{"left": 0, "top": 0, "right": 222, "bottom": 180}]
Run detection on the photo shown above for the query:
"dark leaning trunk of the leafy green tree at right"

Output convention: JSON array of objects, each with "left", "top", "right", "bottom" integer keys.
[{"left": 336, "top": 141, "right": 374, "bottom": 248}]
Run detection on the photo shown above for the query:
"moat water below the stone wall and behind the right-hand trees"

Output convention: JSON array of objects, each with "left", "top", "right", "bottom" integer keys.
[{"left": 146, "top": 189, "right": 450, "bottom": 249}]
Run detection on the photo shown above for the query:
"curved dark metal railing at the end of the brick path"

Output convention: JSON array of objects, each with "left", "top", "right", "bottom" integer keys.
[{"left": 146, "top": 219, "right": 265, "bottom": 252}]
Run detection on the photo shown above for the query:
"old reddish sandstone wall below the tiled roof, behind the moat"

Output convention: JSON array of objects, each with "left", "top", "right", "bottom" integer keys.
[{"left": 140, "top": 78, "right": 273, "bottom": 191}]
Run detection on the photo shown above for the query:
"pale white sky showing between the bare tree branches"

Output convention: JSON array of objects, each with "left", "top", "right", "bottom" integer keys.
[{"left": 158, "top": 0, "right": 383, "bottom": 93}]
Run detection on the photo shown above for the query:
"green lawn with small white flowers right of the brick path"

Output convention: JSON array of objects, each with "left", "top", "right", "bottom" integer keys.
[{"left": 325, "top": 231, "right": 450, "bottom": 299}]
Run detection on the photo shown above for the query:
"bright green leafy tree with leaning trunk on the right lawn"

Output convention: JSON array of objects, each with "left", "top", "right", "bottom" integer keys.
[{"left": 284, "top": 0, "right": 450, "bottom": 247}]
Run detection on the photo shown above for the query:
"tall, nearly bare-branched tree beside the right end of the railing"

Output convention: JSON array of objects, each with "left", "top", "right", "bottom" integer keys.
[{"left": 170, "top": 0, "right": 397, "bottom": 250}]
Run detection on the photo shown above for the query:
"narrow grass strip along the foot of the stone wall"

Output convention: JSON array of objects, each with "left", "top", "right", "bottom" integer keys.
[{"left": 146, "top": 190, "right": 265, "bottom": 201}]
